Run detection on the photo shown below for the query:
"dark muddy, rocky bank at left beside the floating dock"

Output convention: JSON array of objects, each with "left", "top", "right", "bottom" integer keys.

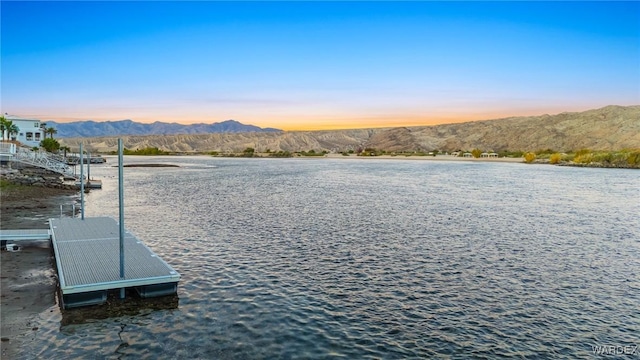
[{"left": 0, "top": 167, "right": 79, "bottom": 359}]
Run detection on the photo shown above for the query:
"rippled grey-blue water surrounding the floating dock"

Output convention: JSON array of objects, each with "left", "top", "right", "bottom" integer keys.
[{"left": 17, "top": 157, "right": 640, "bottom": 359}]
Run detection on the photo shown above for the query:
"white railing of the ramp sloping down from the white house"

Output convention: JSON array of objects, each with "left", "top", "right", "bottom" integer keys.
[{"left": 0, "top": 143, "right": 77, "bottom": 179}]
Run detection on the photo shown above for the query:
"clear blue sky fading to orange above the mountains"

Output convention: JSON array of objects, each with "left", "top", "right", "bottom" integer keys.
[{"left": 0, "top": 1, "right": 640, "bottom": 130}]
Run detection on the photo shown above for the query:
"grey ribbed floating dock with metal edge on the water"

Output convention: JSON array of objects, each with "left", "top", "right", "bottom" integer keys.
[{"left": 49, "top": 217, "right": 180, "bottom": 309}]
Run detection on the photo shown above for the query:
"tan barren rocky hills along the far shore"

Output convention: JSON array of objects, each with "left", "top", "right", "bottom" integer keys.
[{"left": 61, "top": 105, "right": 640, "bottom": 152}]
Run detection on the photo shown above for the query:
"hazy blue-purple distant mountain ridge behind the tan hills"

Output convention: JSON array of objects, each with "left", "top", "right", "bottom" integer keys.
[{"left": 46, "top": 120, "right": 282, "bottom": 138}]
